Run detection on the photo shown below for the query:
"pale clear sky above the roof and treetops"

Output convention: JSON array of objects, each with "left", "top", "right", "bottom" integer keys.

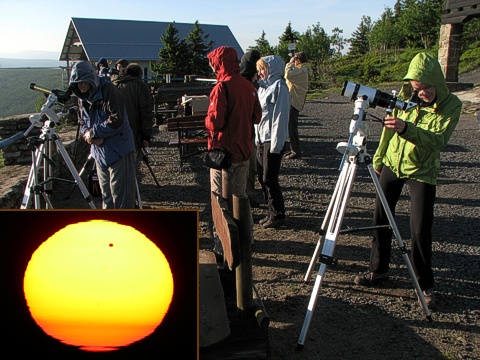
[{"left": 0, "top": 0, "right": 396, "bottom": 59}]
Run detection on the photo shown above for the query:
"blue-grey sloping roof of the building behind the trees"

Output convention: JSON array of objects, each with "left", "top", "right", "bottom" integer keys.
[{"left": 59, "top": 18, "right": 243, "bottom": 61}]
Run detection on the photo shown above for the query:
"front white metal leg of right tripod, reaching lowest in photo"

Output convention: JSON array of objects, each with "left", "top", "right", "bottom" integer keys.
[{"left": 297, "top": 162, "right": 357, "bottom": 350}]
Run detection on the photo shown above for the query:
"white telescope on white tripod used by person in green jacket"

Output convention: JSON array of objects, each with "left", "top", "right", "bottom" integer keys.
[{"left": 297, "top": 81, "right": 432, "bottom": 350}]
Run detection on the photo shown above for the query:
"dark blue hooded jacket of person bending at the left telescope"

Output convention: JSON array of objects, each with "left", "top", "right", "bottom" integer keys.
[{"left": 70, "top": 61, "right": 135, "bottom": 169}]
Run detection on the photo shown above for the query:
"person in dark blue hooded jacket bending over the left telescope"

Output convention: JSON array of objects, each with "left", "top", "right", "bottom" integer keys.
[{"left": 70, "top": 61, "right": 136, "bottom": 209}]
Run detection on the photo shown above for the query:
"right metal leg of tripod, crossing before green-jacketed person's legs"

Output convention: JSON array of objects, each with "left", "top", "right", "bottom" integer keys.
[{"left": 367, "top": 159, "right": 432, "bottom": 321}]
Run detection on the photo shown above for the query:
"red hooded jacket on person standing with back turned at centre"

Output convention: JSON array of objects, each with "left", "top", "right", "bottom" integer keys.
[{"left": 205, "top": 46, "right": 262, "bottom": 163}]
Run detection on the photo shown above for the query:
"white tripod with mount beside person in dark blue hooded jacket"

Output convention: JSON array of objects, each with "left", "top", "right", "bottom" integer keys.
[{"left": 20, "top": 88, "right": 96, "bottom": 209}]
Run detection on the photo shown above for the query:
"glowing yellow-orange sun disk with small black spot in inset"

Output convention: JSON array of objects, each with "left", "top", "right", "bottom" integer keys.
[{"left": 24, "top": 220, "right": 173, "bottom": 351}]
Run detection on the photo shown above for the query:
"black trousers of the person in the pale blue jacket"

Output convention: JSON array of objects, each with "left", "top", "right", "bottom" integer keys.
[{"left": 257, "top": 143, "right": 285, "bottom": 219}]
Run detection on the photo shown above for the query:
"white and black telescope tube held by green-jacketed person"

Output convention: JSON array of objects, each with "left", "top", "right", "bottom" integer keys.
[{"left": 342, "top": 80, "right": 419, "bottom": 111}]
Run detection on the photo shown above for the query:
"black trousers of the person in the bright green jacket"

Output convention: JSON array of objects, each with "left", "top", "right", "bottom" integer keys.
[{"left": 370, "top": 166, "right": 436, "bottom": 290}]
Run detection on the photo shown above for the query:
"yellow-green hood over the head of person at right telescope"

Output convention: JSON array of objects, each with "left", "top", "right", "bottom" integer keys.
[{"left": 400, "top": 53, "right": 450, "bottom": 104}]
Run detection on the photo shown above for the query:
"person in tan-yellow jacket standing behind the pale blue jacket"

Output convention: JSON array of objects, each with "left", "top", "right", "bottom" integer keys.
[{"left": 285, "top": 51, "right": 311, "bottom": 159}]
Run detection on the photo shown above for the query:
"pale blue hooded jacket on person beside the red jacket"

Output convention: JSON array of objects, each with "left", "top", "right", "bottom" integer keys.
[{"left": 255, "top": 55, "right": 290, "bottom": 154}]
